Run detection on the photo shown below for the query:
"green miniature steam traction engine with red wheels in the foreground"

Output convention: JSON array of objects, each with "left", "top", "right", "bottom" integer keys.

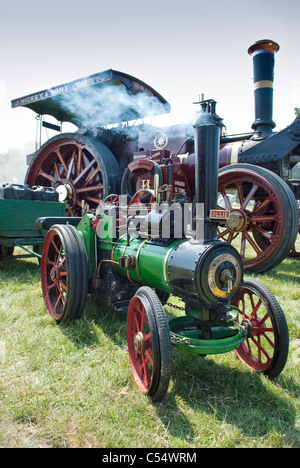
[{"left": 39, "top": 100, "right": 288, "bottom": 401}]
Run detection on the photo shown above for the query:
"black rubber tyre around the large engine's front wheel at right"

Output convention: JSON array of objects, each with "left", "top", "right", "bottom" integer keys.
[{"left": 219, "top": 163, "right": 299, "bottom": 273}]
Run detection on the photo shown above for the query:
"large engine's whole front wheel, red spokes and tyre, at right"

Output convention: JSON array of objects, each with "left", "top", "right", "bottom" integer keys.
[{"left": 218, "top": 164, "right": 299, "bottom": 273}]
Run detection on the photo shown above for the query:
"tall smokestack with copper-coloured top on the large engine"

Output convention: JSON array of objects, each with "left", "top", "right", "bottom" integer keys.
[{"left": 248, "top": 39, "right": 279, "bottom": 138}]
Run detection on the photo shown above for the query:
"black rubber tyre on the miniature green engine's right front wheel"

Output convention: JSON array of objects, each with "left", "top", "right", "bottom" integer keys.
[{"left": 231, "top": 278, "right": 289, "bottom": 378}]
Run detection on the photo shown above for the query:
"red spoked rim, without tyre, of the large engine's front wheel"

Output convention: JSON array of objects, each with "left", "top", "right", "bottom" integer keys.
[{"left": 218, "top": 169, "right": 285, "bottom": 271}]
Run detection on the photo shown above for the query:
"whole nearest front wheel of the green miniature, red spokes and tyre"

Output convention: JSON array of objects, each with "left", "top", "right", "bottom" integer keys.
[{"left": 127, "top": 286, "right": 171, "bottom": 401}]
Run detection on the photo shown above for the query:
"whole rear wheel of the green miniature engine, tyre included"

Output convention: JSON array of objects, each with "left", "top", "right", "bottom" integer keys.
[{"left": 41, "top": 225, "right": 88, "bottom": 322}]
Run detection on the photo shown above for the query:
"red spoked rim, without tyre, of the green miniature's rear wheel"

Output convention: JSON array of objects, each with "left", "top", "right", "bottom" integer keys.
[{"left": 41, "top": 231, "right": 68, "bottom": 319}]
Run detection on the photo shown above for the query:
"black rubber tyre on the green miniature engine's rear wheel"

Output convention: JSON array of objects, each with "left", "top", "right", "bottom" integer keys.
[{"left": 41, "top": 225, "right": 88, "bottom": 323}]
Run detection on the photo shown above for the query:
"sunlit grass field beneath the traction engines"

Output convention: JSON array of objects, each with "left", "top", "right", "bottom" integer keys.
[{"left": 0, "top": 241, "right": 300, "bottom": 448}]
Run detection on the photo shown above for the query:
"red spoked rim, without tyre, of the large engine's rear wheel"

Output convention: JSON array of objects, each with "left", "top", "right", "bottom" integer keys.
[{"left": 26, "top": 137, "right": 104, "bottom": 216}]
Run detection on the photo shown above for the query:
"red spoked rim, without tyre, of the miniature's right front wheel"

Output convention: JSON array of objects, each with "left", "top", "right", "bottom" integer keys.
[{"left": 232, "top": 286, "right": 276, "bottom": 372}]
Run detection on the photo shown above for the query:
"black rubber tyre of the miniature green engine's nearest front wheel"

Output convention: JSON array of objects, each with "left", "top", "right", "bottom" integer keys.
[{"left": 128, "top": 286, "right": 172, "bottom": 402}]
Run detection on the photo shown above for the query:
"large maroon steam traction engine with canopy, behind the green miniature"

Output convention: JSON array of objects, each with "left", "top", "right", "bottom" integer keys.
[{"left": 12, "top": 40, "right": 300, "bottom": 273}]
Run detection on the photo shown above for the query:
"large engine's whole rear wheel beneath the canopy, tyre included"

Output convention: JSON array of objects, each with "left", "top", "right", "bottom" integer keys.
[{"left": 25, "top": 133, "right": 121, "bottom": 216}]
